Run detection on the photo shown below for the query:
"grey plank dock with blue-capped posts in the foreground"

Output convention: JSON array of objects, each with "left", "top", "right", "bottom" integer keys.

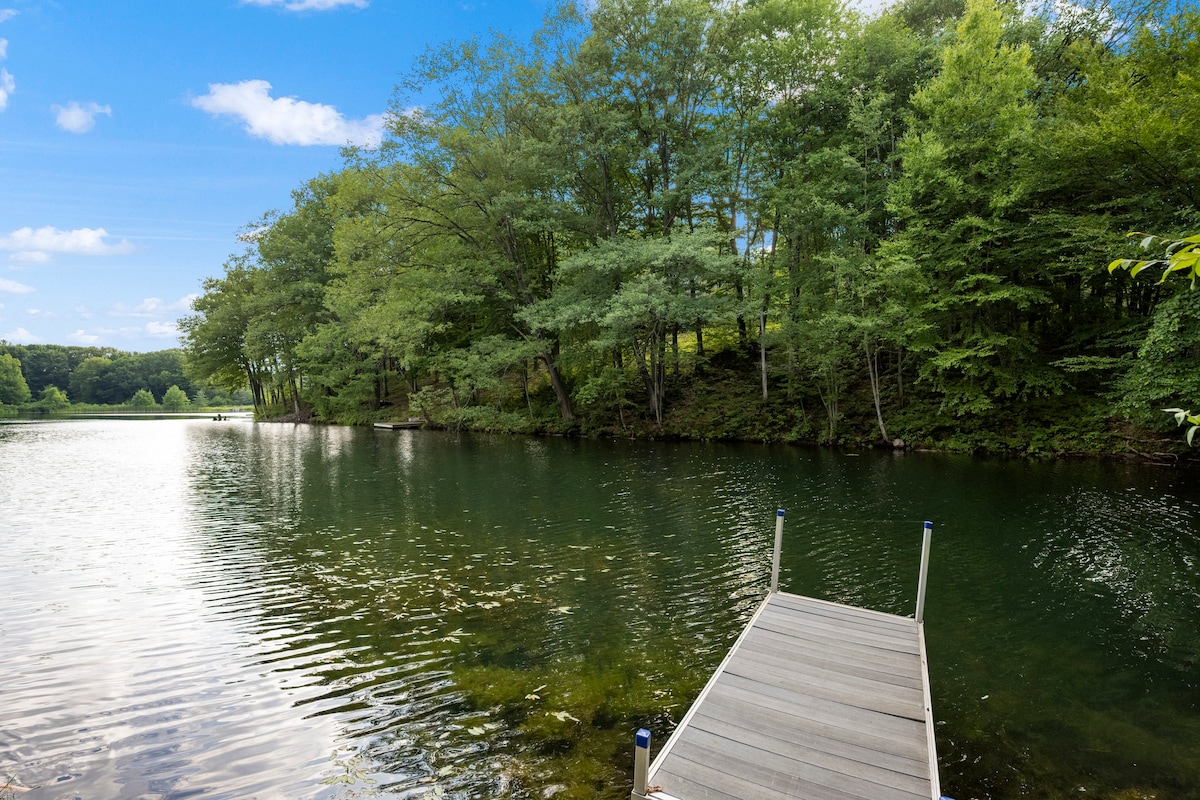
[{"left": 630, "top": 511, "right": 941, "bottom": 800}]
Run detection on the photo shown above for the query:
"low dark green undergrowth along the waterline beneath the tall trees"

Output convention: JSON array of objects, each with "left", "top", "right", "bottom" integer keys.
[{"left": 260, "top": 350, "right": 1192, "bottom": 462}]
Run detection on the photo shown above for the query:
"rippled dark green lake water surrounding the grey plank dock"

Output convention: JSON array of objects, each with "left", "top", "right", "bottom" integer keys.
[{"left": 0, "top": 420, "right": 1200, "bottom": 800}]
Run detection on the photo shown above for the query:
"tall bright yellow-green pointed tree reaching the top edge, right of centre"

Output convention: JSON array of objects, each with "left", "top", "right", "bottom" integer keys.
[{"left": 884, "top": 0, "right": 1063, "bottom": 415}]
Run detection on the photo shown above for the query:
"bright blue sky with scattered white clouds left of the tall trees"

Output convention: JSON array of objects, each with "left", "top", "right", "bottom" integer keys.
[{"left": 0, "top": 0, "right": 547, "bottom": 351}]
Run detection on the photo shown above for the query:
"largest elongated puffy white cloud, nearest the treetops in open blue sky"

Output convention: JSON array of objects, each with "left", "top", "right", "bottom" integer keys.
[{"left": 192, "top": 80, "right": 384, "bottom": 146}]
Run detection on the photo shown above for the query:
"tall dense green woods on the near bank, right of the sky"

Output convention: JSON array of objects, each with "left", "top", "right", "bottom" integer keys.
[{"left": 180, "top": 0, "right": 1200, "bottom": 453}]
